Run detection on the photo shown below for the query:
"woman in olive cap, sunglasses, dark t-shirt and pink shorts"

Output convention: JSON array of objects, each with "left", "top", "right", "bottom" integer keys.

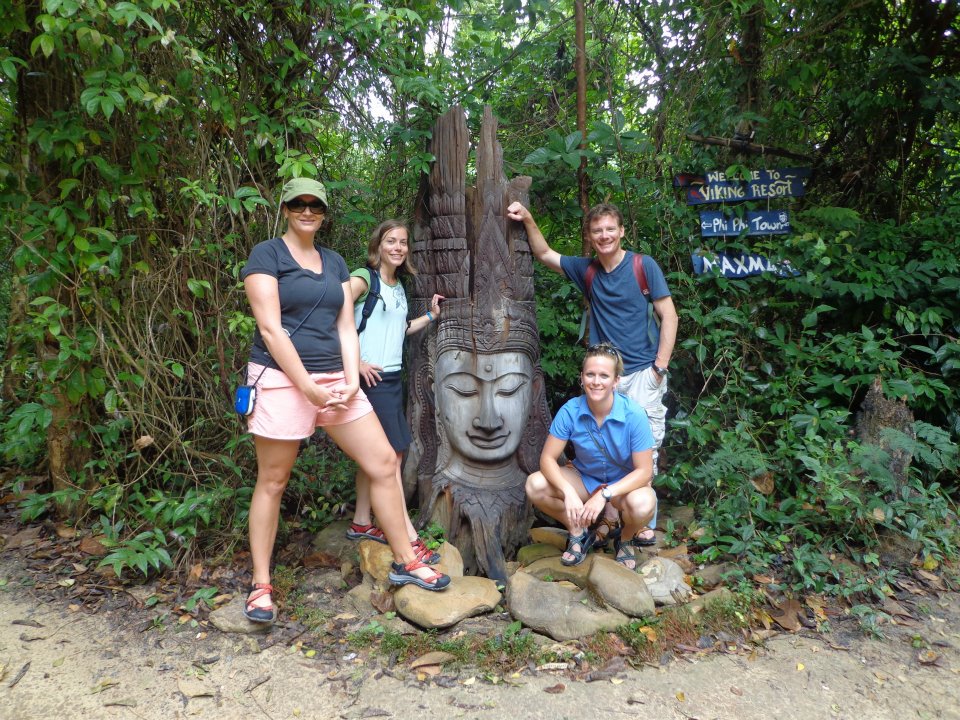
[{"left": 240, "top": 178, "right": 450, "bottom": 622}]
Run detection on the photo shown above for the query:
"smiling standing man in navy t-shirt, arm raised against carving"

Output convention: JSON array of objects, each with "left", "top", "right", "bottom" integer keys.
[{"left": 507, "top": 202, "right": 679, "bottom": 544}]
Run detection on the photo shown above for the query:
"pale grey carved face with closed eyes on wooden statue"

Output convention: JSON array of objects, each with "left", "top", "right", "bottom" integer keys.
[{"left": 434, "top": 349, "right": 533, "bottom": 465}]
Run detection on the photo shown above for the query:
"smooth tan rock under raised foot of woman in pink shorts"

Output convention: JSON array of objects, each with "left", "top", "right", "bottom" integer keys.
[{"left": 394, "top": 576, "right": 501, "bottom": 628}]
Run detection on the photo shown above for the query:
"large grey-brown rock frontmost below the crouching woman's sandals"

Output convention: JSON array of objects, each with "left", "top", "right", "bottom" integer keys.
[{"left": 507, "top": 561, "right": 630, "bottom": 642}]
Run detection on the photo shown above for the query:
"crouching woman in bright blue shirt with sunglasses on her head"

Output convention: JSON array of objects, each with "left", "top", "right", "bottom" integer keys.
[{"left": 527, "top": 343, "right": 657, "bottom": 570}]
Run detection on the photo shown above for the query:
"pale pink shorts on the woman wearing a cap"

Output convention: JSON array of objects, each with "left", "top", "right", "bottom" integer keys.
[{"left": 247, "top": 363, "right": 373, "bottom": 440}]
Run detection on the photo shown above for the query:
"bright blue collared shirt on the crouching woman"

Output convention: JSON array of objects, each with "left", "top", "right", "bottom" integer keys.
[{"left": 550, "top": 393, "right": 653, "bottom": 493}]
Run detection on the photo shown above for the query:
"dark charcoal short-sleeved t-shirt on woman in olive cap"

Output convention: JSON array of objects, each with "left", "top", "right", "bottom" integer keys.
[{"left": 240, "top": 238, "right": 350, "bottom": 372}]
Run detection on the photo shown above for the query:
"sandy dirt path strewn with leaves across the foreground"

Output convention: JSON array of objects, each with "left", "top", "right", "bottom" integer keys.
[{"left": 0, "top": 553, "right": 960, "bottom": 720}]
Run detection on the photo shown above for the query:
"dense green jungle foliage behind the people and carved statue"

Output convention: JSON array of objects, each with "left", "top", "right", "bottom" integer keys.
[{"left": 0, "top": 0, "right": 960, "bottom": 597}]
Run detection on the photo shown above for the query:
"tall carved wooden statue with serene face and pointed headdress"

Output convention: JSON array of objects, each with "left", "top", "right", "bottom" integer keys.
[{"left": 405, "top": 107, "right": 550, "bottom": 579}]
